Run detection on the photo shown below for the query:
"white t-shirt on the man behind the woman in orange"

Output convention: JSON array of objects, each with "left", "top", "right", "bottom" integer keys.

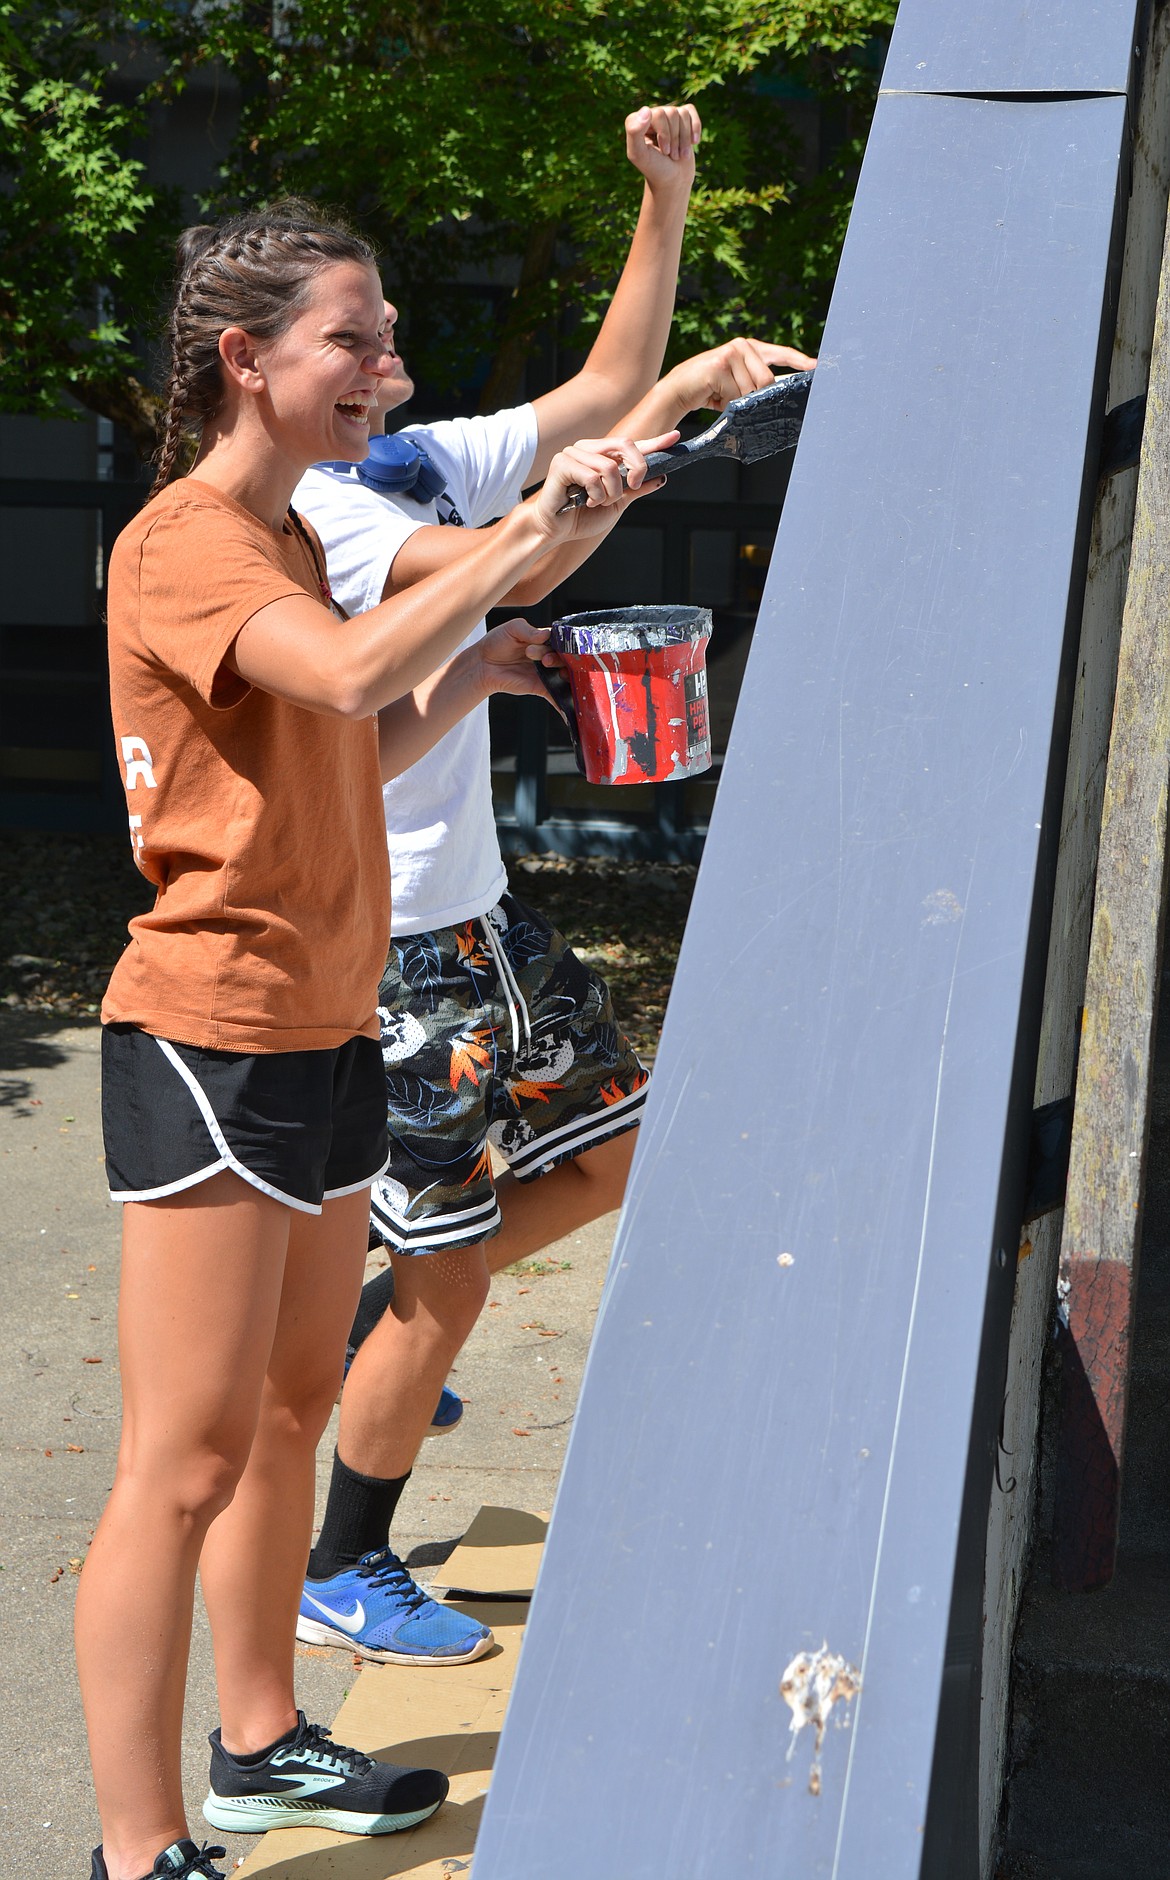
[{"left": 293, "top": 404, "right": 536, "bottom": 934}]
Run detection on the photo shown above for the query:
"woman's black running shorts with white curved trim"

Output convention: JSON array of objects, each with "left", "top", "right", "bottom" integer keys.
[{"left": 102, "top": 1025, "right": 389, "bottom": 1214}]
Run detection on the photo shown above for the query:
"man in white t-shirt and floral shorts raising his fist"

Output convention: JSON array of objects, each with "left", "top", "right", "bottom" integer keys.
[{"left": 293, "top": 105, "right": 813, "bottom": 1664}]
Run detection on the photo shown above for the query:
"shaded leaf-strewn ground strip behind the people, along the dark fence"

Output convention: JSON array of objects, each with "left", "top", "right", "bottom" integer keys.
[{"left": 0, "top": 833, "right": 696, "bottom": 1057}]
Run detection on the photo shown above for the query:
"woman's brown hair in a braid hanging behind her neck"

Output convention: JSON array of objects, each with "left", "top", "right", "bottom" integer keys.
[{"left": 150, "top": 196, "right": 376, "bottom": 496}]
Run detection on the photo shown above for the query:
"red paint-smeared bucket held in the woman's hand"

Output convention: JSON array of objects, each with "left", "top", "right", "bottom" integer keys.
[{"left": 540, "top": 607, "right": 711, "bottom": 784}]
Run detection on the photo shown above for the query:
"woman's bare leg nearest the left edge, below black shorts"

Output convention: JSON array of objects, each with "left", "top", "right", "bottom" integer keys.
[{"left": 77, "top": 1171, "right": 290, "bottom": 1880}]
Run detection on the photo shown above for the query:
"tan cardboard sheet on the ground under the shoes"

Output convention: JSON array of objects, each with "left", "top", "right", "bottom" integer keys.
[{"left": 235, "top": 1508, "right": 547, "bottom": 1880}]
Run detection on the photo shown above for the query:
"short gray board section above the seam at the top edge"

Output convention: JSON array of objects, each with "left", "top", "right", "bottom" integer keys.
[{"left": 882, "top": 0, "right": 1144, "bottom": 96}]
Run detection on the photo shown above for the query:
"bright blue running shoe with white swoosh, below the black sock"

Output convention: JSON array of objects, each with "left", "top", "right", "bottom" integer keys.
[{"left": 297, "top": 1547, "right": 493, "bottom": 1664}]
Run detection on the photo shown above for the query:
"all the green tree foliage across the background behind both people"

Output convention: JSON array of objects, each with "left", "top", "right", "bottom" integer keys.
[{"left": 0, "top": 0, "right": 895, "bottom": 447}]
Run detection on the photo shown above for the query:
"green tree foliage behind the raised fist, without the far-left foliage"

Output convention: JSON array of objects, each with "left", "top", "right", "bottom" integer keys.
[{"left": 192, "top": 0, "right": 893, "bottom": 408}]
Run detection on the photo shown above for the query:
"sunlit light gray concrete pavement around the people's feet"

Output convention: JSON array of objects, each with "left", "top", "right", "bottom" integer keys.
[{"left": 0, "top": 1011, "right": 615, "bottom": 1880}]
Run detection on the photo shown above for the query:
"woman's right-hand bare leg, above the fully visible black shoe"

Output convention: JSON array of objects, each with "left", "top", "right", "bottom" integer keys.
[{"left": 199, "top": 1188, "right": 369, "bottom": 1756}]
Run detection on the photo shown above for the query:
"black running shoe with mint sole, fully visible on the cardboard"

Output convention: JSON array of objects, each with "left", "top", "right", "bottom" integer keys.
[{"left": 204, "top": 1711, "right": 450, "bottom": 1834}]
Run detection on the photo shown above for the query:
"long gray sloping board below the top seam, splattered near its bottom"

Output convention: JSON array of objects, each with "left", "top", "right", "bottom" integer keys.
[{"left": 476, "top": 96, "right": 1125, "bottom": 1880}]
